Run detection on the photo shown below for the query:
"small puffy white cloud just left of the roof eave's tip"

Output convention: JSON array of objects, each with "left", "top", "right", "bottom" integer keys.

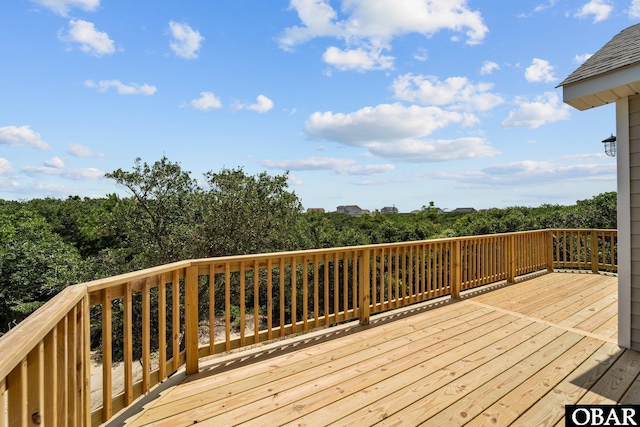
[{"left": 502, "top": 92, "right": 570, "bottom": 129}]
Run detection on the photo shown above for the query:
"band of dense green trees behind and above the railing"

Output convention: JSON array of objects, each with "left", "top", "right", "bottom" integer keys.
[{"left": 0, "top": 157, "right": 617, "bottom": 333}]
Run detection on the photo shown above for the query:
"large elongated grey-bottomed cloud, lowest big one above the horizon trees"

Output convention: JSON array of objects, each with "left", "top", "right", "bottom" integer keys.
[{"left": 305, "top": 104, "right": 497, "bottom": 162}]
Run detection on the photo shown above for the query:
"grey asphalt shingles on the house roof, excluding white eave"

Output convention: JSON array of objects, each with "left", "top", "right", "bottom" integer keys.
[{"left": 558, "top": 24, "right": 640, "bottom": 86}]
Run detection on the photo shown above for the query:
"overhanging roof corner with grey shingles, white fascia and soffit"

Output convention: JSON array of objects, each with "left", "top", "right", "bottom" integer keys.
[{"left": 558, "top": 24, "right": 640, "bottom": 110}]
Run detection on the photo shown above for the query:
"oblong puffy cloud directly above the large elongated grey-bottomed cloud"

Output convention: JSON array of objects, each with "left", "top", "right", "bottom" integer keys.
[{"left": 391, "top": 73, "right": 504, "bottom": 111}]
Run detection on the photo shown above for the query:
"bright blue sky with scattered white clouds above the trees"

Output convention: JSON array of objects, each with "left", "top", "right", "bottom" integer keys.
[{"left": 0, "top": 0, "right": 640, "bottom": 212}]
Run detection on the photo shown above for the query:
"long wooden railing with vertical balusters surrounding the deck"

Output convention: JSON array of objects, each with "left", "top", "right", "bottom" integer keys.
[{"left": 0, "top": 230, "right": 617, "bottom": 427}]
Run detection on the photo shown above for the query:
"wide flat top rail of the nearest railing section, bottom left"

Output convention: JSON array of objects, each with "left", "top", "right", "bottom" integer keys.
[{"left": 0, "top": 285, "right": 87, "bottom": 379}]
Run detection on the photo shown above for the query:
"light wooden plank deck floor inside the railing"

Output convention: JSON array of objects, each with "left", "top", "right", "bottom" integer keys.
[{"left": 119, "top": 273, "right": 640, "bottom": 427}]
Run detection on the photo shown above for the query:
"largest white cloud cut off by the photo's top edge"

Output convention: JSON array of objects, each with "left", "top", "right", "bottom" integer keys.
[{"left": 278, "top": 0, "right": 489, "bottom": 71}]
